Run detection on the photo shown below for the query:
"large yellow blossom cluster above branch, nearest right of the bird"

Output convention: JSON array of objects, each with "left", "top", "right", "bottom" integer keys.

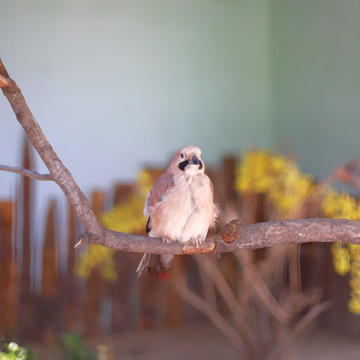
[{"left": 235, "top": 150, "right": 316, "bottom": 218}]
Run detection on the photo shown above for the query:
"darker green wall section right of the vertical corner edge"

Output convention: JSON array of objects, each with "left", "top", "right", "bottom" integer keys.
[{"left": 271, "top": 0, "right": 360, "bottom": 176}]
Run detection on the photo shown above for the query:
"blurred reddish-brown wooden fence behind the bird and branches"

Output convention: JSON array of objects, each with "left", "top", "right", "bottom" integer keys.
[{"left": 0, "top": 138, "right": 359, "bottom": 342}]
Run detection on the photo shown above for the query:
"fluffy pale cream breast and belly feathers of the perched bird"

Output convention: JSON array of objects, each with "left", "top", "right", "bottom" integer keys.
[{"left": 147, "top": 174, "right": 216, "bottom": 243}]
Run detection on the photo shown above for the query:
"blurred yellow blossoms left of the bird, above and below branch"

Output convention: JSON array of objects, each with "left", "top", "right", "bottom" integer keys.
[{"left": 75, "top": 170, "right": 153, "bottom": 281}]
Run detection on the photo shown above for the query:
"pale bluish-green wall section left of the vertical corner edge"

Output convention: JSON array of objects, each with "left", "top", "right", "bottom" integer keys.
[{"left": 0, "top": 0, "right": 271, "bottom": 200}]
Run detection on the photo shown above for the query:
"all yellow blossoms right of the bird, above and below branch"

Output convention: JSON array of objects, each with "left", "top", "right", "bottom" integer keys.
[{"left": 235, "top": 150, "right": 360, "bottom": 314}]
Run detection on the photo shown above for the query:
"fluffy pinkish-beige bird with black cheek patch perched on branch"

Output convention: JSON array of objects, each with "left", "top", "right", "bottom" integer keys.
[{"left": 136, "top": 145, "right": 218, "bottom": 276}]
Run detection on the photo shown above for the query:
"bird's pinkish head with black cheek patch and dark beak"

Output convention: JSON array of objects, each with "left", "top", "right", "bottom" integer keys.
[{"left": 170, "top": 145, "right": 205, "bottom": 175}]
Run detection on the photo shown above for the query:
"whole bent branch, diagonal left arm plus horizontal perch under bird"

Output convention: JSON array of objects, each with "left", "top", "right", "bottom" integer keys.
[{"left": 0, "top": 59, "right": 360, "bottom": 254}]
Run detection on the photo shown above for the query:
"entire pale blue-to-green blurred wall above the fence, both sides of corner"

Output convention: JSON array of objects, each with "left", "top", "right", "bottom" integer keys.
[{"left": 0, "top": 0, "right": 360, "bottom": 191}]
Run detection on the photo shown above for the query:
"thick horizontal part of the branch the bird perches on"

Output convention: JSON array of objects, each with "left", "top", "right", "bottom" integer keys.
[{"left": 80, "top": 219, "right": 360, "bottom": 255}]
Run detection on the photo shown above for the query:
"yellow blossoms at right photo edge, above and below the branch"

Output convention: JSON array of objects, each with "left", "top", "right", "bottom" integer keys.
[{"left": 321, "top": 187, "right": 360, "bottom": 314}]
